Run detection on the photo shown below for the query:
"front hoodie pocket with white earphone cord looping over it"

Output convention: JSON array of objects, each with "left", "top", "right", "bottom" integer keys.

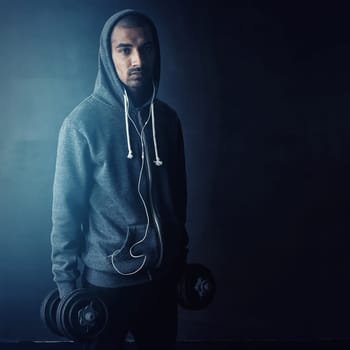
[{"left": 112, "top": 225, "right": 159, "bottom": 276}]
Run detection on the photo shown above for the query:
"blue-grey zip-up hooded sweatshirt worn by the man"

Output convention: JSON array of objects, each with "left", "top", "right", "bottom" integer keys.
[{"left": 51, "top": 10, "right": 188, "bottom": 297}]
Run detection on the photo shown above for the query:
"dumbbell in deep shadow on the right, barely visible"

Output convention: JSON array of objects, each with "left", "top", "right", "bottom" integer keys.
[{"left": 177, "top": 264, "right": 216, "bottom": 310}]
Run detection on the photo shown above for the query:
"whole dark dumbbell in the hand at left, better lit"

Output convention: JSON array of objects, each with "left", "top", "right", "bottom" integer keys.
[{"left": 40, "top": 288, "right": 108, "bottom": 342}]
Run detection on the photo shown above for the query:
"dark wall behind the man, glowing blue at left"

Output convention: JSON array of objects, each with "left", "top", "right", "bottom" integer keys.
[{"left": 0, "top": 0, "right": 350, "bottom": 340}]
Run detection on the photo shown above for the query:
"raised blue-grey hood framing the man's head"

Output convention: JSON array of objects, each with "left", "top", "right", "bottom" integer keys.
[{"left": 93, "top": 10, "right": 160, "bottom": 106}]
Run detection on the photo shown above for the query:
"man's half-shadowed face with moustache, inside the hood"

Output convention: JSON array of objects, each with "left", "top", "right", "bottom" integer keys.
[{"left": 111, "top": 25, "right": 156, "bottom": 91}]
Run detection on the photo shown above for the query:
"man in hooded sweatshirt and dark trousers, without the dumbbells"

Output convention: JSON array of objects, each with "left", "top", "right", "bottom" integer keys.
[{"left": 51, "top": 10, "right": 188, "bottom": 350}]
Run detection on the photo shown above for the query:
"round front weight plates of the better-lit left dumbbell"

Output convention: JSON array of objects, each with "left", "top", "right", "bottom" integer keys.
[{"left": 56, "top": 289, "right": 108, "bottom": 341}]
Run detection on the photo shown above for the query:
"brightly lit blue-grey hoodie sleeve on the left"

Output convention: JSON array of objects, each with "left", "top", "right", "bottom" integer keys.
[{"left": 51, "top": 119, "right": 90, "bottom": 298}]
